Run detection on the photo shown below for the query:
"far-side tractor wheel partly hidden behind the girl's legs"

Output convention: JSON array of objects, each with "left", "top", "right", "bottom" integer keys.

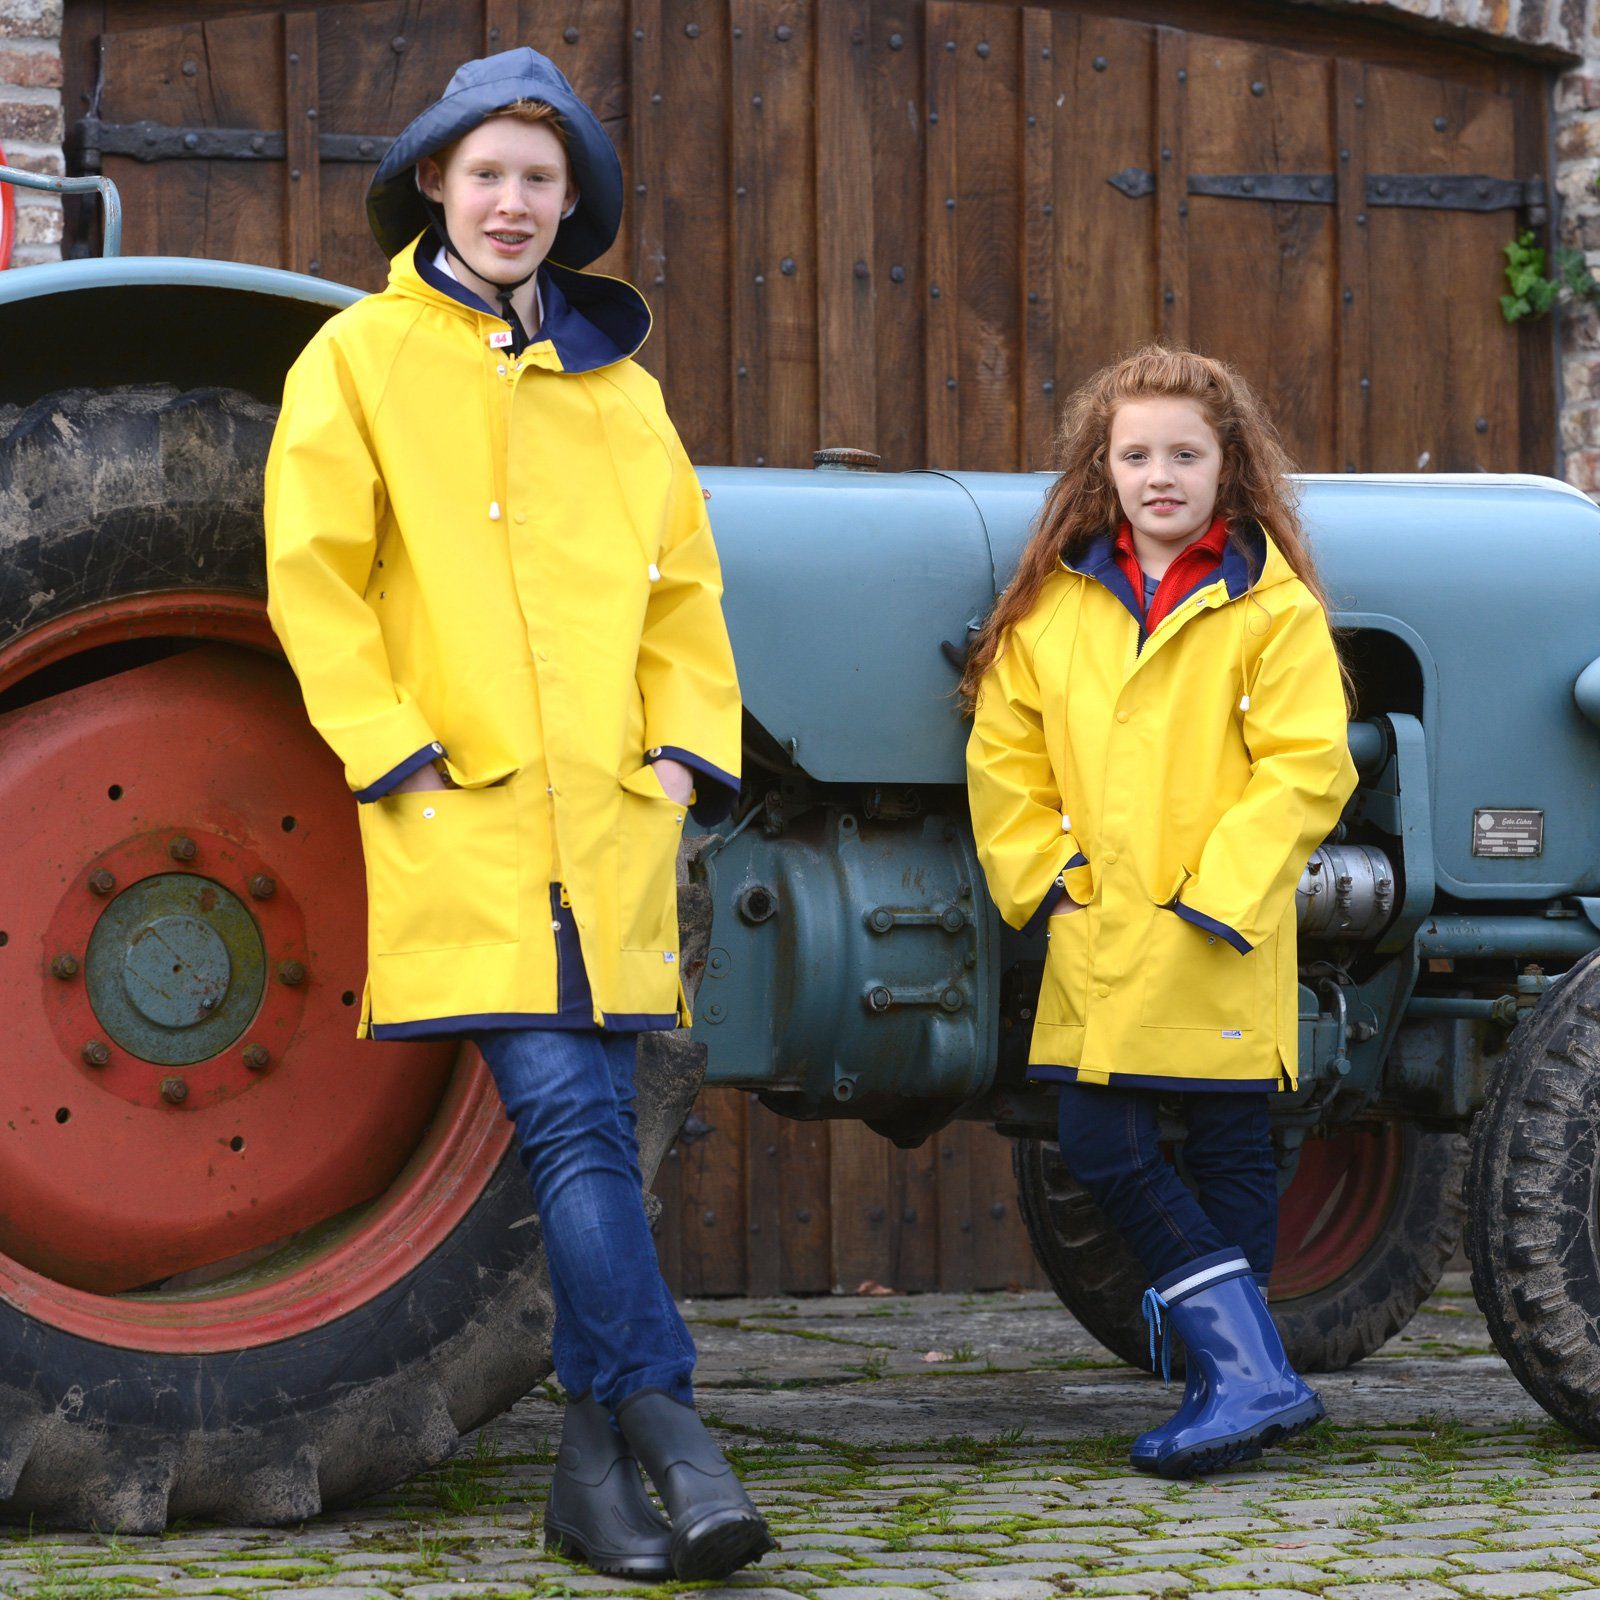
[{"left": 1013, "top": 1123, "right": 1466, "bottom": 1373}]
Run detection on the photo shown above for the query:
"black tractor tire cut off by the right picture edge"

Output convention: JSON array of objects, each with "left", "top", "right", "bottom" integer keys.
[{"left": 1467, "top": 957, "right": 1600, "bottom": 1442}]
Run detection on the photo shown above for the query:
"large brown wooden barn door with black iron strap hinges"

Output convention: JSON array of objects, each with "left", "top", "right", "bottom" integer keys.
[{"left": 64, "top": 0, "right": 1555, "bottom": 1294}]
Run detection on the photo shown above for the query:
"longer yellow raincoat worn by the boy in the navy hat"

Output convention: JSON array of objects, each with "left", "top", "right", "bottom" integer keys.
[{"left": 266, "top": 236, "right": 739, "bottom": 1038}]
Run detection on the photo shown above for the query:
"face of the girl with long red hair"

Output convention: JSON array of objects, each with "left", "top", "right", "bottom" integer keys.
[{"left": 1109, "top": 398, "right": 1222, "bottom": 562}]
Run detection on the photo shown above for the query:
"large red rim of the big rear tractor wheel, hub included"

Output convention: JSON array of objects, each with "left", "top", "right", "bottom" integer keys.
[{"left": 0, "top": 594, "right": 510, "bottom": 1352}]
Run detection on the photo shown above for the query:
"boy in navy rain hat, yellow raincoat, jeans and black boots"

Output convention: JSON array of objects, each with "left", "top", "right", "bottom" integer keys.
[{"left": 266, "top": 50, "right": 771, "bottom": 1579}]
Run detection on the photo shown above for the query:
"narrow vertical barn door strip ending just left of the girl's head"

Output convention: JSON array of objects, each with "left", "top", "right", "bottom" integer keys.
[{"left": 1016, "top": 6, "right": 1056, "bottom": 472}]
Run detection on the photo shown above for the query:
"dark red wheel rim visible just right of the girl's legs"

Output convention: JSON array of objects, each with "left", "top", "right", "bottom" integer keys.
[{"left": 1272, "top": 1123, "right": 1405, "bottom": 1301}]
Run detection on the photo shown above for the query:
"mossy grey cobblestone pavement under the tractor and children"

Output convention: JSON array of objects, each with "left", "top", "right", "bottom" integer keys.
[{"left": 0, "top": 1275, "right": 1600, "bottom": 1600}]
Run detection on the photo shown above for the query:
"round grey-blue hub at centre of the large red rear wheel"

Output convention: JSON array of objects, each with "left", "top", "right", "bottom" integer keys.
[{"left": 85, "top": 872, "right": 266, "bottom": 1067}]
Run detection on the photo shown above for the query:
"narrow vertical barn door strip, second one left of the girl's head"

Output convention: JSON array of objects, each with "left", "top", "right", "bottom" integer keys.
[{"left": 923, "top": 0, "right": 962, "bottom": 467}]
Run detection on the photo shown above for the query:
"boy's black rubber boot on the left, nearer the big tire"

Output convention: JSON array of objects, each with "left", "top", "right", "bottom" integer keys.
[{"left": 544, "top": 1395, "right": 672, "bottom": 1581}]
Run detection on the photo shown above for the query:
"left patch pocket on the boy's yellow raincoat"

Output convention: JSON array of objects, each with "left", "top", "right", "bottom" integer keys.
[{"left": 360, "top": 789, "right": 522, "bottom": 955}]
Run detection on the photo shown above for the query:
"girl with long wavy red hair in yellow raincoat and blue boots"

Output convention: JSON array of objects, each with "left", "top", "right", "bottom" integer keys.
[{"left": 962, "top": 346, "right": 1355, "bottom": 1477}]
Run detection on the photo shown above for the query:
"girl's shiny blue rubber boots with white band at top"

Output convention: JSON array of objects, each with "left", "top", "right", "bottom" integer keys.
[{"left": 1155, "top": 1250, "right": 1325, "bottom": 1478}]
